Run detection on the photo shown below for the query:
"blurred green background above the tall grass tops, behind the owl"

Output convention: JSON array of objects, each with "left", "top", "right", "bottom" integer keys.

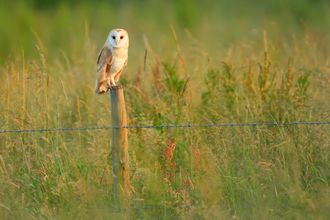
[{"left": 0, "top": 0, "right": 330, "bottom": 68}]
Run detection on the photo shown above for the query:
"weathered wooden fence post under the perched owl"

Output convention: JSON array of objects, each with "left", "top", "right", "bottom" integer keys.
[{"left": 110, "top": 86, "right": 130, "bottom": 211}]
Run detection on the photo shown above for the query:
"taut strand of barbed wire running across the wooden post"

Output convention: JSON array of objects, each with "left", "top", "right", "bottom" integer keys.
[{"left": 0, "top": 122, "right": 330, "bottom": 133}]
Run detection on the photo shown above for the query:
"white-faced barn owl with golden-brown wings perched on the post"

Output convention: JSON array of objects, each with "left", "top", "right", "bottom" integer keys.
[{"left": 95, "top": 29, "right": 129, "bottom": 95}]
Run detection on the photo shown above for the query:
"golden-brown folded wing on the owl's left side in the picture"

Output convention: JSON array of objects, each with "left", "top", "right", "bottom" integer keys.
[{"left": 95, "top": 45, "right": 113, "bottom": 94}]
